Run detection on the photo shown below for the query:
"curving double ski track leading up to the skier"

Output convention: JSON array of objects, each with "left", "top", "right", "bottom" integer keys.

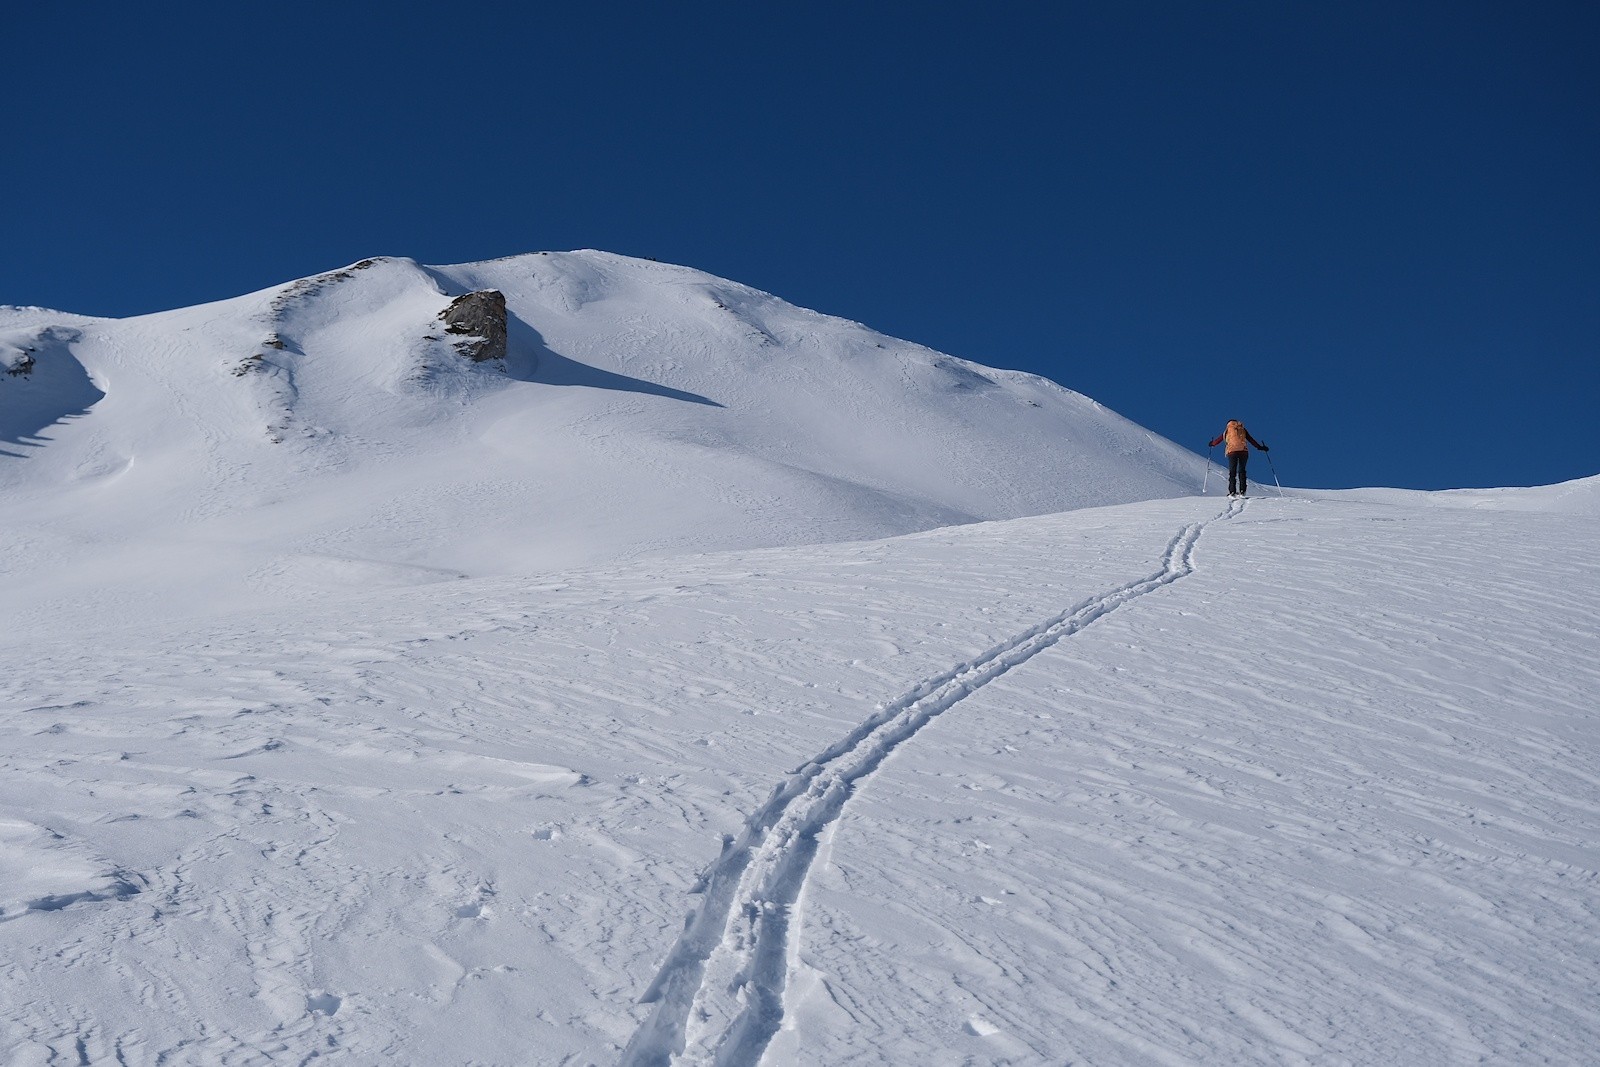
[{"left": 621, "top": 499, "right": 1245, "bottom": 1067}]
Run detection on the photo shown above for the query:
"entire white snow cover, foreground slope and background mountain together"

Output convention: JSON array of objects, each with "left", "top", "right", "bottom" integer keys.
[{"left": 0, "top": 253, "right": 1600, "bottom": 1067}]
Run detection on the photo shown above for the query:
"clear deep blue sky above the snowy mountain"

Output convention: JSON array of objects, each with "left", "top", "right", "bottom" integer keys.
[{"left": 0, "top": 0, "right": 1600, "bottom": 488}]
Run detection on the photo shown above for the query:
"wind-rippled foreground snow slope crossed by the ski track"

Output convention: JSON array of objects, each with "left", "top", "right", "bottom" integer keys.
[{"left": 0, "top": 491, "right": 1600, "bottom": 1065}]
